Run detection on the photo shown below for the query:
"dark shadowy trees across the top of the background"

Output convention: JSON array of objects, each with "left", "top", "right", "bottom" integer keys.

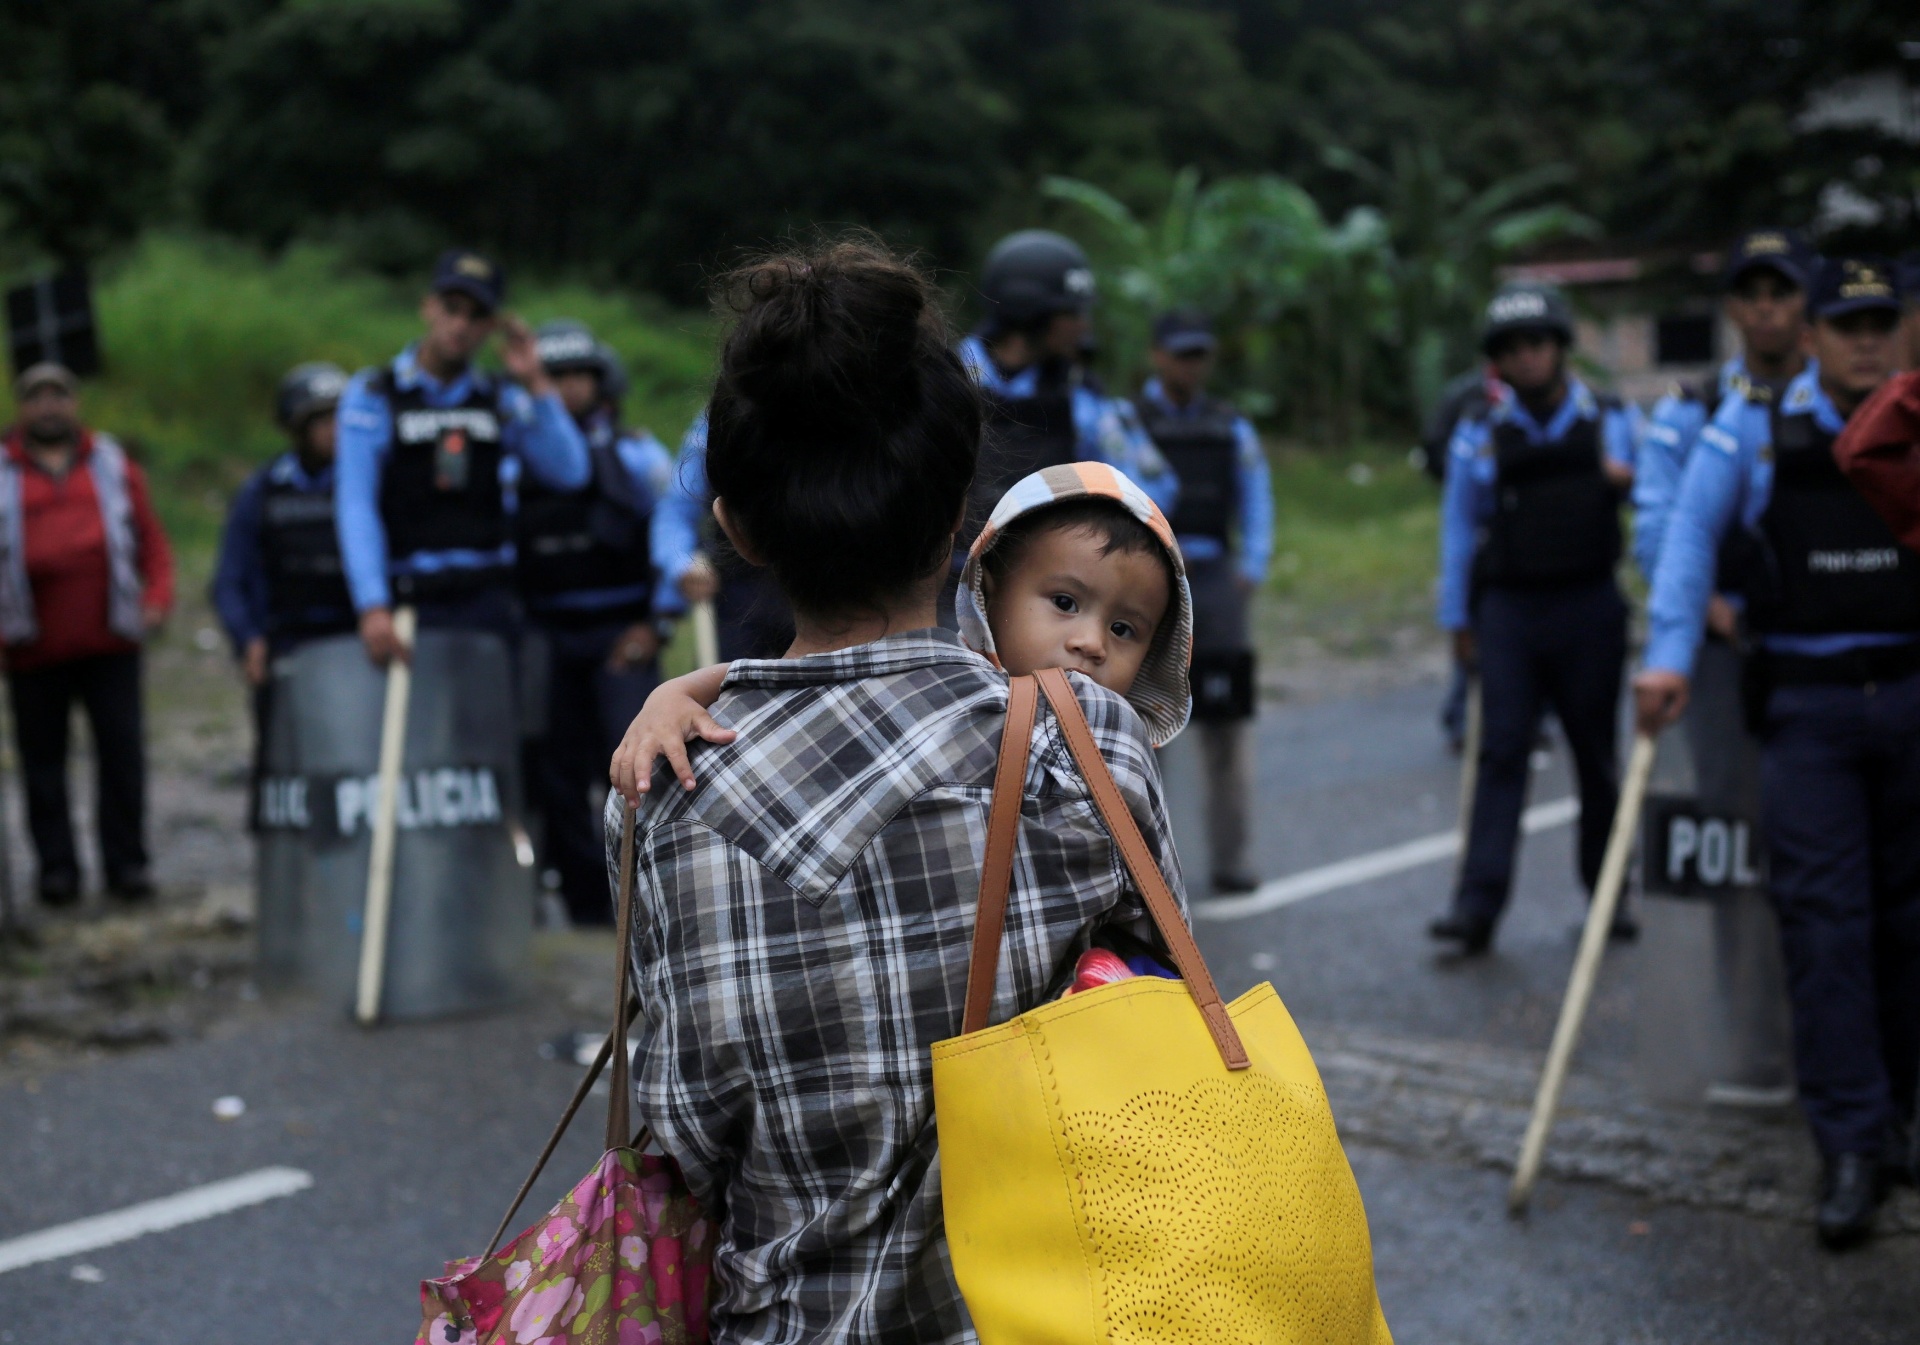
[{"left": 11, "top": 0, "right": 1920, "bottom": 303}]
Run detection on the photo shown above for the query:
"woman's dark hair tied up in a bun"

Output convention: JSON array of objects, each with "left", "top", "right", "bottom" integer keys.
[{"left": 707, "top": 238, "right": 981, "bottom": 614}]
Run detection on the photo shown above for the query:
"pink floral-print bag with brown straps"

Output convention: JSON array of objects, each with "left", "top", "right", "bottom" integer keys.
[{"left": 415, "top": 808, "right": 714, "bottom": 1345}]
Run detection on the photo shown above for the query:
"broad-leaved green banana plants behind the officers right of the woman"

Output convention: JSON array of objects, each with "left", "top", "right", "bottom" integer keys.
[{"left": 1043, "top": 160, "right": 1599, "bottom": 445}]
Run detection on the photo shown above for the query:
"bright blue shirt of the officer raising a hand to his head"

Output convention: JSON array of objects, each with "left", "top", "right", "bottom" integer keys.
[{"left": 334, "top": 345, "right": 591, "bottom": 612}]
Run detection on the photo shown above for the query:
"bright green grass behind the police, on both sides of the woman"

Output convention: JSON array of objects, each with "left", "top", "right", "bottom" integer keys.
[{"left": 0, "top": 234, "right": 1438, "bottom": 662}]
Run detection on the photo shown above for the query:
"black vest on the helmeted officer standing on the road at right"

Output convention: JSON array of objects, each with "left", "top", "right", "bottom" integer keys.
[{"left": 1475, "top": 404, "right": 1620, "bottom": 587}]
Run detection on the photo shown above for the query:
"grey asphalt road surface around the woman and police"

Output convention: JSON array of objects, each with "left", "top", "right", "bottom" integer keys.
[{"left": 0, "top": 675, "right": 1920, "bottom": 1345}]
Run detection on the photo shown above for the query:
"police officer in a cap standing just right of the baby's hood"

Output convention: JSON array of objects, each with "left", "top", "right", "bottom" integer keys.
[{"left": 1135, "top": 313, "right": 1273, "bottom": 894}]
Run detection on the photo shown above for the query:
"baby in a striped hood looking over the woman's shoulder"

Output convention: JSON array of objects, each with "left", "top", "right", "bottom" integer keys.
[{"left": 612, "top": 462, "right": 1192, "bottom": 802}]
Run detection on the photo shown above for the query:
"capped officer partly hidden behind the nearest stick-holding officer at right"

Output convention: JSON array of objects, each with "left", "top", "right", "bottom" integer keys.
[{"left": 1634, "top": 228, "right": 1816, "bottom": 815}]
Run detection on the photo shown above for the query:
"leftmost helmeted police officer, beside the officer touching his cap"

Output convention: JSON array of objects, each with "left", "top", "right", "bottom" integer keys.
[{"left": 211, "top": 365, "right": 357, "bottom": 817}]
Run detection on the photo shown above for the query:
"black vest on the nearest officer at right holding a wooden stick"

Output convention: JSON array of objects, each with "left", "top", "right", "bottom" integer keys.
[{"left": 1747, "top": 407, "right": 1920, "bottom": 635}]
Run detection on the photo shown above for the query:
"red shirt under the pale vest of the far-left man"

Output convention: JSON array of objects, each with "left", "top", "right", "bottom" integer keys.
[{"left": 6, "top": 426, "right": 173, "bottom": 670}]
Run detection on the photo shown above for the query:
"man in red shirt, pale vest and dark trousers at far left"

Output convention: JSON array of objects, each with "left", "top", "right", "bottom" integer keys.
[{"left": 0, "top": 365, "right": 173, "bottom": 906}]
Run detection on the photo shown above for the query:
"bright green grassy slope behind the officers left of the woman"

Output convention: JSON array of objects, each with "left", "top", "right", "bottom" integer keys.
[{"left": 0, "top": 236, "right": 712, "bottom": 552}]
